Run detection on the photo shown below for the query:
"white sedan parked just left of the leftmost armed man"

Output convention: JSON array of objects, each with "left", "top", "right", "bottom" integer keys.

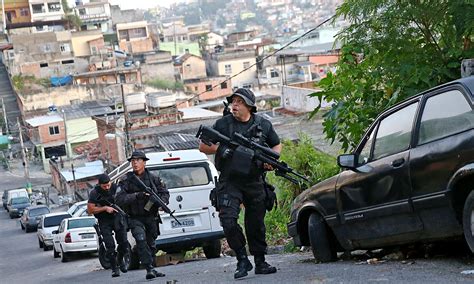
[{"left": 53, "top": 217, "right": 97, "bottom": 262}]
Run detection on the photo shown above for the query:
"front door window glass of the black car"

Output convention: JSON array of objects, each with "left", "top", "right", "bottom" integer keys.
[{"left": 374, "top": 102, "right": 418, "bottom": 160}]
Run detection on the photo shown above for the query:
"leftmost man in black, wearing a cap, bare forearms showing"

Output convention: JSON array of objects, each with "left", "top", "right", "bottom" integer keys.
[{"left": 87, "top": 174, "right": 128, "bottom": 277}]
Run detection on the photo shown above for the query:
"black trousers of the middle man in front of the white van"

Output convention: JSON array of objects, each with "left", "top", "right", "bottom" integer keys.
[{"left": 128, "top": 216, "right": 159, "bottom": 267}]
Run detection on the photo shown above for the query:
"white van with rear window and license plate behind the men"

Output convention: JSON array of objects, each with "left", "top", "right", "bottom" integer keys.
[{"left": 110, "top": 150, "right": 224, "bottom": 267}]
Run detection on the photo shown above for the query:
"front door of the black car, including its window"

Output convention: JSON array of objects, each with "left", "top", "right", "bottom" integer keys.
[{"left": 336, "top": 99, "right": 422, "bottom": 247}]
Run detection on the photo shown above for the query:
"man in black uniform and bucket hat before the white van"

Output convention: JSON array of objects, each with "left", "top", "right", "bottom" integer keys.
[{"left": 117, "top": 151, "right": 170, "bottom": 279}]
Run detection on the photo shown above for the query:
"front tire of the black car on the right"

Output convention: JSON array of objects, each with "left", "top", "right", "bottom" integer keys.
[{"left": 308, "top": 213, "right": 337, "bottom": 262}]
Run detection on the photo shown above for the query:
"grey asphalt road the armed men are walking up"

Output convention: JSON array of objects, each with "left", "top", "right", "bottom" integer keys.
[{"left": 0, "top": 194, "right": 474, "bottom": 283}]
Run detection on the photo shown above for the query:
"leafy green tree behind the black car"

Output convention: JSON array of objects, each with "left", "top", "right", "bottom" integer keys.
[{"left": 312, "top": 0, "right": 474, "bottom": 150}]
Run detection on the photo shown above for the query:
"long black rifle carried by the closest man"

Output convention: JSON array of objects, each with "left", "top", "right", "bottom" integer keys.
[{"left": 196, "top": 125, "right": 308, "bottom": 184}]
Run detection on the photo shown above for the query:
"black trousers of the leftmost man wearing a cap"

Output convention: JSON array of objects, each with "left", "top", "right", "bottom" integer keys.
[{"left": 99, "top": 214, "right": 128, "bottom": 257}]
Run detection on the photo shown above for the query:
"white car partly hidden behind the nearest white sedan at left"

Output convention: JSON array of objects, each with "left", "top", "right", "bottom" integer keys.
[{"left": 36, "top": 212, "right": 71, "bottom": 251}]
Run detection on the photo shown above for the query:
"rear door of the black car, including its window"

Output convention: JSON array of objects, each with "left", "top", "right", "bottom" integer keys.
[{"left": 410, "top": 85, "right": 474, "bottom": 237}]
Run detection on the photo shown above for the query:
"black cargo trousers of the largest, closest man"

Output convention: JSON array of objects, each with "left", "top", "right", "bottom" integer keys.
[{"left": 218, "top": 181, "right": 267, "bottom": 255}]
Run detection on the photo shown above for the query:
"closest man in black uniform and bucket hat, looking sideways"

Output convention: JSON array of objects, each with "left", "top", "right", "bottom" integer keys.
[{"left": 199, "top": 88, "right": 282, "bottom": 279}]
